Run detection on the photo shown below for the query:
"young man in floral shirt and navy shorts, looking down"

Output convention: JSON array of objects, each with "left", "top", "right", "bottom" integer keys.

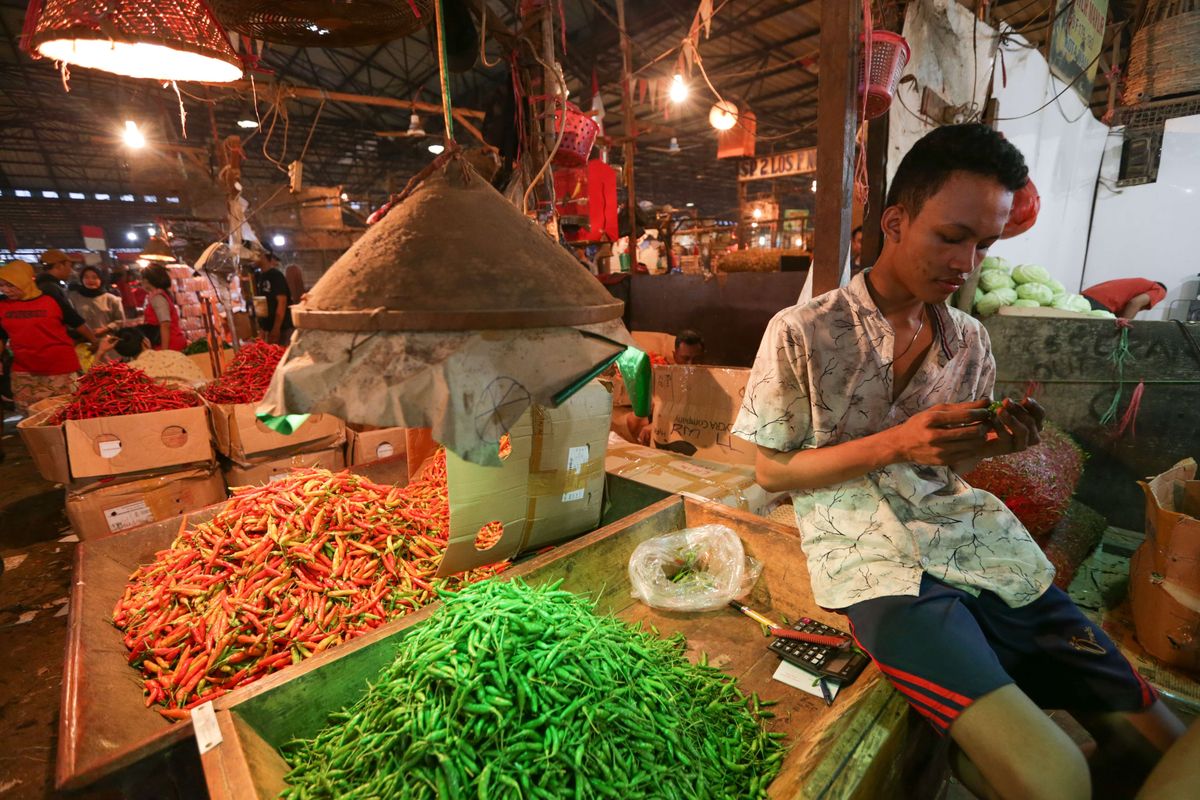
[{"left": 733, "top": 125, "right": 1181, "bottom": 799}]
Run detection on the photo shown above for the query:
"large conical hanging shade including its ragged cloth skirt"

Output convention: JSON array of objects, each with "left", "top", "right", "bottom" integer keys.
[{"left": 258, "top": 154, "right": 632, "bottom": 464}]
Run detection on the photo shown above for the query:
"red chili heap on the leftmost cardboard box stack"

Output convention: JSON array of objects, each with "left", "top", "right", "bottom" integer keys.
[{"left": 52, "top": 363, "right": 200, "bottom": 425}]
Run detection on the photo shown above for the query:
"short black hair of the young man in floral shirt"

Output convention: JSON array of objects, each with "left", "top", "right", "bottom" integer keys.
[{"left": 887, "top": 122, "right": 1030, "bottom": 216}]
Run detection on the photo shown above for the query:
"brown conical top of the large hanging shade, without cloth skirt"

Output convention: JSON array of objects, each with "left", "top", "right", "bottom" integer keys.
[{"left": 293, "top": 157, "right": 623, "bottom": 331}]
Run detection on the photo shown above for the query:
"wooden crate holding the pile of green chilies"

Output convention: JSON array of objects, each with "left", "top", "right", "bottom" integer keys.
[{"left": 202, "top": 497, "right": 907, "bottom": 800}]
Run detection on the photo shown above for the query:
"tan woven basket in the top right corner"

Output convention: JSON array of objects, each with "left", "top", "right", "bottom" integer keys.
[{"left": 1122, "top": 0, "right": 1200, "bottom": 106}]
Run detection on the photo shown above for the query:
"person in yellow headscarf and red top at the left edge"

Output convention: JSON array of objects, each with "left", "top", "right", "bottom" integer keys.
[{"left": 0, "top": 261, "right": 79, "bottom": 414}]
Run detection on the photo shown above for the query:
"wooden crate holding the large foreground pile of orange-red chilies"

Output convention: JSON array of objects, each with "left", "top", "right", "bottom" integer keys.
[{"left": 55, "top": 457, "right": 667, "bottom": 796}]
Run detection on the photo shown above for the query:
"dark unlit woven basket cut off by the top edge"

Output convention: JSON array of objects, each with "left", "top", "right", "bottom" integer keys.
[{"left": 211, "top": 0, "right": 433, "bottom": 47}]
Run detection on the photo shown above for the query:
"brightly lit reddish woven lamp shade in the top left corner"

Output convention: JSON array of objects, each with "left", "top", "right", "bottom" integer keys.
[{"left": 25, "top": 0, "right": 242, "bottom": 83}]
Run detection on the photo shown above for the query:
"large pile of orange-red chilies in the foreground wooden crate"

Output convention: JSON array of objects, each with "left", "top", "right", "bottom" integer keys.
[{"left": 113, "top": 453, "right": 506, "bottom": 720}]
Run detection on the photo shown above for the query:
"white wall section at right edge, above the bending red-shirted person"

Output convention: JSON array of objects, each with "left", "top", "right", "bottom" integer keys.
[{"left": 1084, "top": 115, "right": 1200, "bottom": 319}]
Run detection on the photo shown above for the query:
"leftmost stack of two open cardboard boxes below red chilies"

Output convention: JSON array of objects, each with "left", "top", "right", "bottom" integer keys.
[{"left": 17, "top": 404, "right": 224, "bottom": 540}]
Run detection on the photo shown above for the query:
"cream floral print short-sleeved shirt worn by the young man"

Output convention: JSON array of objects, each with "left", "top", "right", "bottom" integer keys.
[{"left": 733, "top": 273, "right": 1055, "bottom": 608}]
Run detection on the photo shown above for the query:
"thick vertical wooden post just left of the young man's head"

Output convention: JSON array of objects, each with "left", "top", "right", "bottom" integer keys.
[{"left": 812, "top": 2, "right": 859, "bottom": 296}]
